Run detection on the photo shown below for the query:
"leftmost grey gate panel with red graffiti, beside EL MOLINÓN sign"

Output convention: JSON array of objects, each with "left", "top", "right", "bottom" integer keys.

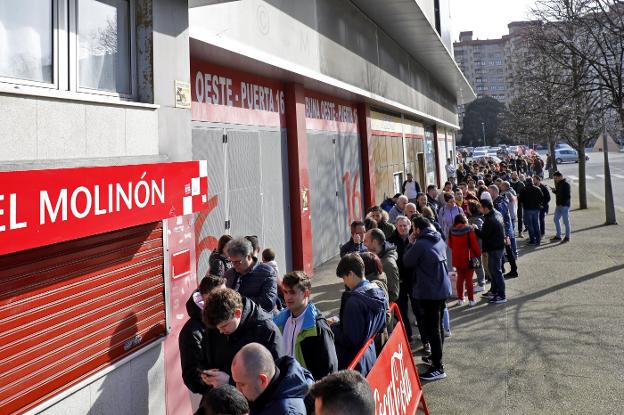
[{"left": 192, "top": 126, "right": 226, "bottom": 278}]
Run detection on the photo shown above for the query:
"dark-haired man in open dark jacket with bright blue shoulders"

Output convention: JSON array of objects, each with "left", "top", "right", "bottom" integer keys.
[{"left": 273, "top": 271, "right": 338, "bottom": 380}]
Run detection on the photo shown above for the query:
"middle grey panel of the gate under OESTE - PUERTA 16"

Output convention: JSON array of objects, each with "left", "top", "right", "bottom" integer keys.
[{"left": 227, "top": 129, "right": 262, "bottom": 237}]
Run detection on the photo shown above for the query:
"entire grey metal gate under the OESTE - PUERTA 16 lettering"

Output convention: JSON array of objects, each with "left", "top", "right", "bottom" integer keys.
[{"left": 193, "top": 123, "right": 292, "bottom": 278}]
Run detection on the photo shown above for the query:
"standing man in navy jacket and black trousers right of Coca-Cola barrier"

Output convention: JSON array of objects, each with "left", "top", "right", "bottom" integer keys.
[{"left": 403, "top": 216, "right": 451, "bottom": 381}]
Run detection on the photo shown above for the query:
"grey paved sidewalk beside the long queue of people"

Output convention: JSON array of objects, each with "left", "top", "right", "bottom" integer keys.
[{"left": 313, "top": 192, "right": 624, "bottom": 414}]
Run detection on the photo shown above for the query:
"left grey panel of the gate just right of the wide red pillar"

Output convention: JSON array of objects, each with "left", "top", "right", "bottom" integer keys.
[{"left": 307, "top": 131, "right": 338, "bottom": 266}]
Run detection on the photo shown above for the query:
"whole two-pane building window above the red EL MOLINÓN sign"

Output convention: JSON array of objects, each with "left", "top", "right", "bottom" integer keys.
[{"left": 0, "top": 0, "right": 136, "bottom": 98}]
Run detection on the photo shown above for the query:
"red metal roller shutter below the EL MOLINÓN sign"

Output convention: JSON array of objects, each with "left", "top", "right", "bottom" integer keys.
[{"left": 0, "top": 223, "right": 166, "bottom": 414}]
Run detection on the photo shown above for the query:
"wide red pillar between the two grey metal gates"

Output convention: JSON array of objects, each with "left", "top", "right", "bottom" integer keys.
[{"left": 285, "top": 83, "right": 313, "bottom": 275}]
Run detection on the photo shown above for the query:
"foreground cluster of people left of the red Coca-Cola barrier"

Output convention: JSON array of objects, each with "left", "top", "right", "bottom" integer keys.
[{"left": 179, "top": 234, "right": 382, "bottom": 415}]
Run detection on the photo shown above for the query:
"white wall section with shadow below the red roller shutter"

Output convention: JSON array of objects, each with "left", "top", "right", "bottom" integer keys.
[{"left": 39, "top": 343, "right": 166, "bottom": 415}]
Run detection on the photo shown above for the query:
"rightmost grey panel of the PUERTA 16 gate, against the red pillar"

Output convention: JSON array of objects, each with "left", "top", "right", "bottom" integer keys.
[{"left": 260, "top": 130, "right": 292, "bottom": 274}]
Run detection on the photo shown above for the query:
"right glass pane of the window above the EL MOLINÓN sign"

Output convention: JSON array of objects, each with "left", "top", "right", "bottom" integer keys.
[{"left": 76, "top": 0, "right": 132, "bottom": 95}]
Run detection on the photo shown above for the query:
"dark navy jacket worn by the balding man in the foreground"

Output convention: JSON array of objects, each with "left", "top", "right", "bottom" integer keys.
[{"left": 250, "top": 356, "right": 314, "bottom": 413}]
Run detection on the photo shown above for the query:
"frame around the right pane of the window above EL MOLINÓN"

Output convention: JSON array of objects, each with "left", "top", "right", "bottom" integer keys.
[{"left": 71, "top": 0, "right": 137, "bottom": 100}]
